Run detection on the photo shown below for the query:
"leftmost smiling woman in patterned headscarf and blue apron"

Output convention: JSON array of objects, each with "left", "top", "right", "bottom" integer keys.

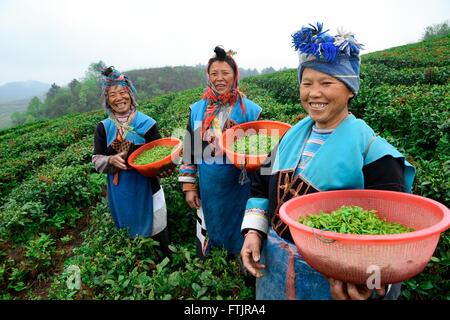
[{"left": 92, "top": 67, "right": 171, "bottom": 254}]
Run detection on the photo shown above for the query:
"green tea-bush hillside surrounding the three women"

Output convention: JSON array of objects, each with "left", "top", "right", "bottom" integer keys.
[{"left": 0, "top": 36, "right": 450, "bottom": 300}]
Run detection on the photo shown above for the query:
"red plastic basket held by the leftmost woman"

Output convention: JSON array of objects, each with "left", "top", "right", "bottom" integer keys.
[{"left": 128, "top": 138, "right": 182, "bottom": 177}]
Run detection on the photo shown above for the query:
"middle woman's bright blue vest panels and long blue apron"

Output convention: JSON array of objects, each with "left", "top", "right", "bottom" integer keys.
[{"left": 180, "top": 98, "right": 261, "bottom": 254}]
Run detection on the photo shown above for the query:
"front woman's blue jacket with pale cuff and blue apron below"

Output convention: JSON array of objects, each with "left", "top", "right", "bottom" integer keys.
[{"left": 242, "top": 115, "right": 415, "bottom": 300}]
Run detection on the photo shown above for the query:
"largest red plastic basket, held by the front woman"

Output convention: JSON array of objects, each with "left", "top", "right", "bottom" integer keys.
[{"left": 280, "top": 190, "right": 450, "bottom": 284}]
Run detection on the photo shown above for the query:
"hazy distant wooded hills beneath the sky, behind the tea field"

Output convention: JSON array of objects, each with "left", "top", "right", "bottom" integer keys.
[{"left": 11, "top": 61, "right": 282, "bottom": 125}]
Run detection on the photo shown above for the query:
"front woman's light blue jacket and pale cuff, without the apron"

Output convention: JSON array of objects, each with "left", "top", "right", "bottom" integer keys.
[{"left": 242, "top": 114, "right": 415, "bottom": 238}]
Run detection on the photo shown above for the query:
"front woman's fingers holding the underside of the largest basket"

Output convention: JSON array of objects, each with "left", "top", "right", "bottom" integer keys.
[{"left": 328, "top": 278, "right": 385, "bottom": 300}]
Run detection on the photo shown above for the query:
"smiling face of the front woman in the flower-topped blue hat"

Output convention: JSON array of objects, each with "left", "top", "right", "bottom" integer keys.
[{"left": 300, "top": 68, "right": 354, "bottom": 129}]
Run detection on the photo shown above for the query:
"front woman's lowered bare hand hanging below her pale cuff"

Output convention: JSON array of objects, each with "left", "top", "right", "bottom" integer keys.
[{"left": 241, "top": 233, "right": 266, "bottom": 278}]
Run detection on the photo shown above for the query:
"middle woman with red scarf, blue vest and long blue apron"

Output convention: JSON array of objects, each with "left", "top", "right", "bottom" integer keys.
[{"left": 179, "top": 47, "right": 261, "bottom": 257}]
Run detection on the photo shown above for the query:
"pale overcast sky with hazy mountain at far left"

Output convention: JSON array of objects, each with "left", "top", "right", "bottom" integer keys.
[{"left": 0, "top": 0, "right": 450, "bottom": 85}]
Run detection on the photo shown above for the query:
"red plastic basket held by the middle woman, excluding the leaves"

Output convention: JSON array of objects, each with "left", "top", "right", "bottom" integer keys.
[{"left": 219, "top": 120, "right": 291, "bottom": 171}]
